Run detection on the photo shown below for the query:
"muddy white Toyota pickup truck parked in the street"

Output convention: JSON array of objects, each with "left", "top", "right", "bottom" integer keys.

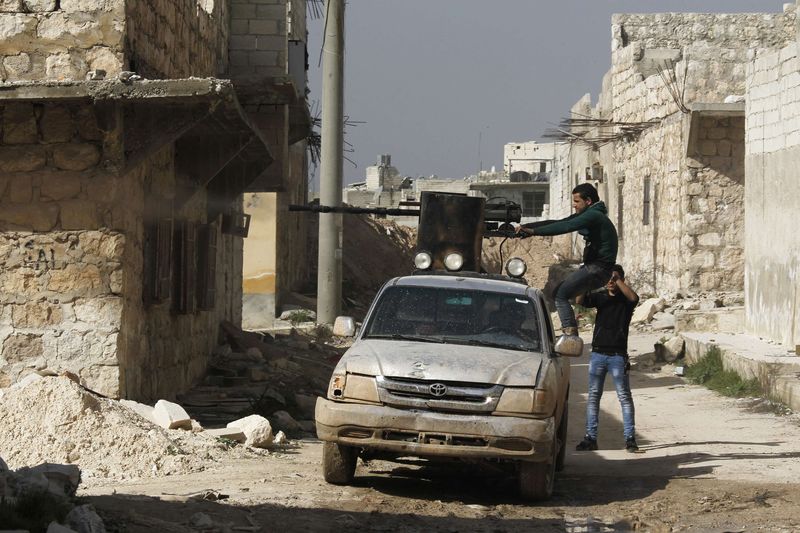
[{"left": 315, "top": 260, "right": 580, "bottom": 500}]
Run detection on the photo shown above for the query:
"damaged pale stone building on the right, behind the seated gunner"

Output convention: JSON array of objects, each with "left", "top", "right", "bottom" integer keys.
[{"left": 551, "top": 5, "right": 796, "bottom": 301}]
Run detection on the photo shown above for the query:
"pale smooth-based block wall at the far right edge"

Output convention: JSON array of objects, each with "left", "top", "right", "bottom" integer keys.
[{"left": 745, "top": 43, "right": 800, "bottom": 345}]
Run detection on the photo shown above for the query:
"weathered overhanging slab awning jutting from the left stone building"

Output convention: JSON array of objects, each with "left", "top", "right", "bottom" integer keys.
[{"left": 0, "top": 78, "right": 282, "bottom": 217}]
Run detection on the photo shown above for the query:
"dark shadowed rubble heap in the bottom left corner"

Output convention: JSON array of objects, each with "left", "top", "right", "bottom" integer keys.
[{"left": 0, "top": 458, "right": 106, "bottom": 533}]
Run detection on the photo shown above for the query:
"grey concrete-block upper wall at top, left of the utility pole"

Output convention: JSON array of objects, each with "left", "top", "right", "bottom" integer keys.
[{"left": 230, "top": 0, "right": 288, "bottom": 79}]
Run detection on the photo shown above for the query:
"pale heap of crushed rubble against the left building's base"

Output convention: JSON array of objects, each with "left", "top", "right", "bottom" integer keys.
[{"left": 0, "top": 377, "right": 268, "bottom": 479}]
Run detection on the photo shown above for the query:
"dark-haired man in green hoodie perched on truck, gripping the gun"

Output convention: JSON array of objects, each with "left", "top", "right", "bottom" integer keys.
[{"left": 517, "top": 183, "right": 618, "bottom": 345}]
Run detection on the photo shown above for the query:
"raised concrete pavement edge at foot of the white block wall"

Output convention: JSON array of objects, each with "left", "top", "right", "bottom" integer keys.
[{"left": 681, "top": 332, "right": 800, "bottom": 411}]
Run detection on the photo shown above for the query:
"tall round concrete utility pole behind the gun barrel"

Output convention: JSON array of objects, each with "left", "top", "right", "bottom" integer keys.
[{"left": 317, "top": 0, "right": 345, "bottom": 324}]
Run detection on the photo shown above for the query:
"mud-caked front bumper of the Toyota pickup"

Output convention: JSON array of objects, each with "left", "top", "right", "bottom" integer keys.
[{"left": 314, "top": 398, "right": 555, "bottom": 461}]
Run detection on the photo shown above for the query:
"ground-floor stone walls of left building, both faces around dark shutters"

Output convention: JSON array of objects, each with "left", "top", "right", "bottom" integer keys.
[{"left": 0, "top": 103, "right": 242, "bottom": 400}]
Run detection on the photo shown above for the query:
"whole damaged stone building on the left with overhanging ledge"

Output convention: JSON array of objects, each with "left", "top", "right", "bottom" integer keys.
[{"left": 0, "top": 0, "right": 308, "bottom": 401}]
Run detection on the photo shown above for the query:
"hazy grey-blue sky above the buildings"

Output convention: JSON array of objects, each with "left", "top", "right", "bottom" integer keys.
[{"left": 309, "top": 0, "right": 785, "bottom": 188}]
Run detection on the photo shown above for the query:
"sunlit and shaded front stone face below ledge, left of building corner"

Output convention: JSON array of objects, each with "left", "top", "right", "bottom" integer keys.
[{"left": 0, "top": 103, "right": 129, "bottom": 395}]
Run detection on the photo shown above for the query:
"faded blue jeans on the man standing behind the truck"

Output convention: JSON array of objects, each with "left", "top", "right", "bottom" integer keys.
[{"left": 586, "top": 352, "right": 636, "bottom": 440}]
